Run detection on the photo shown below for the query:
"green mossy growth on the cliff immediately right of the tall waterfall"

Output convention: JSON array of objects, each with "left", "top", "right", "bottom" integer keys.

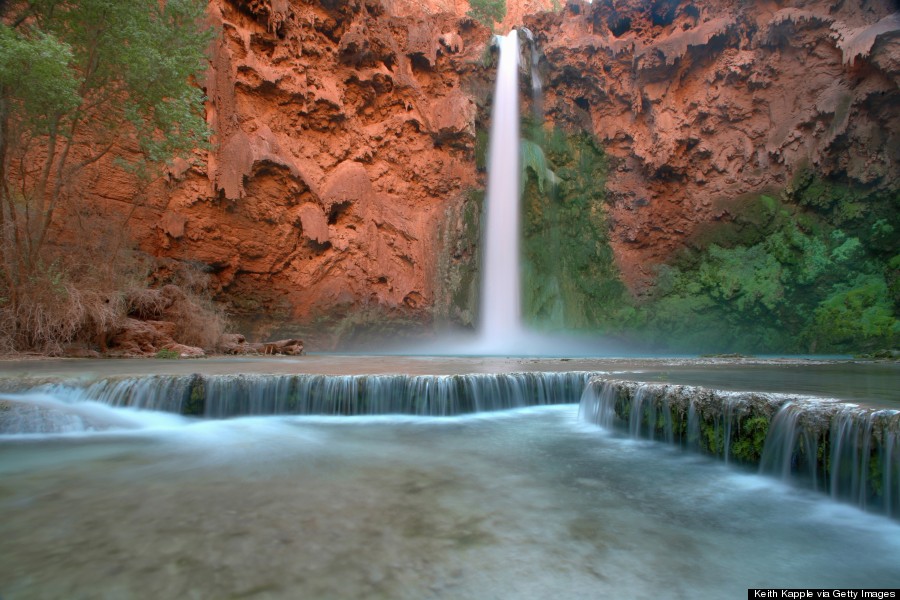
[{"left": 522, "top": 126, "right": 630, "bottom": 330}]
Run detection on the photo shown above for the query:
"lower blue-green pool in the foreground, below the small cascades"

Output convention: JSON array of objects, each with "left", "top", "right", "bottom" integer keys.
[{"left": 0, "top": 406, "right": 900, "bottom": 600}]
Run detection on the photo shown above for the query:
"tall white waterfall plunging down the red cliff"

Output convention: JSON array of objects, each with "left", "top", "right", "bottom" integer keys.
[{"left": 478, "top": 30, "right": 524, "bottom": 352}]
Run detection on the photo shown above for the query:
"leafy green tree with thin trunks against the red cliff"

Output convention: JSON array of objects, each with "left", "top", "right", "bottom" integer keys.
[{"left": 0, "top": 0, "right": 213, "bottom": 350}]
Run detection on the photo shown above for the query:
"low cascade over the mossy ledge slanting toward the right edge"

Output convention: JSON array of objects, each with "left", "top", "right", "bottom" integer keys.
[{"left": 579, "top": 378, "right": 900, "bottom": 518}]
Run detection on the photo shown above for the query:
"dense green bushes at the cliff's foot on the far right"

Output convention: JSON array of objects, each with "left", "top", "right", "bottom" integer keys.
[{"left": 635, "top": 185, "right": 900, "bottom": 352}]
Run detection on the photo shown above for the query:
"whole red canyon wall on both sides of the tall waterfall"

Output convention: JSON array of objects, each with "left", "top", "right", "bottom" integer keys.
[{"left": 67, "top": 0, "right": 900, "bottom": 350}]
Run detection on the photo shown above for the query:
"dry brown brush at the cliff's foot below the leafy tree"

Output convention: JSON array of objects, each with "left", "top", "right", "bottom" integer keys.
[{"left": 0, "top": 192, "right": 232, "bottom": 354}]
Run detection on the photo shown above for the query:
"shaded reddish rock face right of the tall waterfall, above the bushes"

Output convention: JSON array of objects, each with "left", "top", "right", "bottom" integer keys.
[{"left": 526, "top": 0, "right": 900, "bottom": 292}]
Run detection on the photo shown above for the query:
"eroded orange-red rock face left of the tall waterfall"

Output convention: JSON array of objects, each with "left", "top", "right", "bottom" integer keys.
[{"left": 123, "top": 0, "right": 489, "bottom": 335}]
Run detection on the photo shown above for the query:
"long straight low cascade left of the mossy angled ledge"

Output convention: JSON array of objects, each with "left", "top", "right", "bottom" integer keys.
[{"left": 8, "top": 372, "right": 593, "bottom": 419}]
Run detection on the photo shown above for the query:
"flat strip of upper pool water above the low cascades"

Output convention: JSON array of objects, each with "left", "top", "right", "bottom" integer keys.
[{"left": 0, "top": 354, "right": 900, "bottom": 408}]
